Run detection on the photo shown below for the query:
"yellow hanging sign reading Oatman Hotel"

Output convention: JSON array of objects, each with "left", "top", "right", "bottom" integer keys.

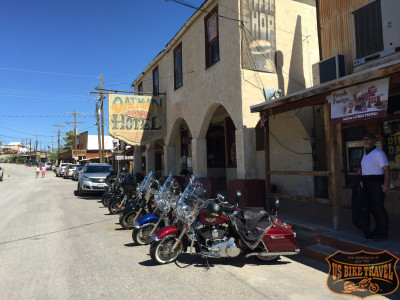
[{"left": 108, "top": 94, "right": 165, "bottom": 146}]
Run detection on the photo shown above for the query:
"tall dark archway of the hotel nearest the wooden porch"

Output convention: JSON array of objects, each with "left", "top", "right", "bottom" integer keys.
[{"left": 206, "top": 105, "right": 237, "bottom": 191}]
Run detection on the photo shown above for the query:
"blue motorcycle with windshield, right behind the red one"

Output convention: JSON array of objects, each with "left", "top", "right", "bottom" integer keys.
[{"left": 132, "top": 174, "right": 181, "bottom": 245}]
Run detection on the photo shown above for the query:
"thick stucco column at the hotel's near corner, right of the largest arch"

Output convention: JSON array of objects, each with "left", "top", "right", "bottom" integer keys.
[{"left": 235, "top": 126, "right": 257, "bottom": 179}]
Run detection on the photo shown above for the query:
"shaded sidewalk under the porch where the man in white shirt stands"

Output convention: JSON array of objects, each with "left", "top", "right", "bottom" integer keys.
[{"left": 278, "top": 199, "right": 400, "bottom": 255}]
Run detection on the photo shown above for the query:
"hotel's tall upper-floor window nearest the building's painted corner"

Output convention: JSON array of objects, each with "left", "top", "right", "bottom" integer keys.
[{"left": 204, "top": 6, "right": 219, "bottom": 68}]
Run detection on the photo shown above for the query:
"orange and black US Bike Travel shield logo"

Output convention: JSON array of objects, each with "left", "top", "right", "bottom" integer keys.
[{"left": 326, "top": 251, "right": 399, "bottom": 298}]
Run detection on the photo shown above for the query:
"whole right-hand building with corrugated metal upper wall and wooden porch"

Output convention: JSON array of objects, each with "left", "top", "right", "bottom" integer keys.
[{"left": 251, "top": 0, "right": 400, "bottom": 228}]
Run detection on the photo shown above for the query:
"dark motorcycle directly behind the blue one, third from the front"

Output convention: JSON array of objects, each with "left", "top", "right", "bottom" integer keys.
[{"left": 119, "top": 172, "right": 161, "bottom": 229}]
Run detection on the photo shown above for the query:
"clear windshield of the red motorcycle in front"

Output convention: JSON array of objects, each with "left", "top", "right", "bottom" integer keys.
[{"left": 176, "top": 175, "right": 211, "bottom": 223}]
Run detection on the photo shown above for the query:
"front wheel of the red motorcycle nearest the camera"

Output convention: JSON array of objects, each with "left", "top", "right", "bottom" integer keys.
[{"left": 150, "top": 237, "right": 183, "bottom": 265}]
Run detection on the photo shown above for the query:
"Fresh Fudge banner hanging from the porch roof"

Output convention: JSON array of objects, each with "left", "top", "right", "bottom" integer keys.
[{"left": 327, "top": 78, "right": 389, "bottom": 124}]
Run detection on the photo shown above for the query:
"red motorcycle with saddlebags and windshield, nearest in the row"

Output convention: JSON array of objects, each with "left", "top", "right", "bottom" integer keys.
[{"left": 150, "top": 175, "right": 300, "bottom": 264}]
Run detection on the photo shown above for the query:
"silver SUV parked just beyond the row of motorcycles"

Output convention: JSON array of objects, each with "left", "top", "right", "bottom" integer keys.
[{"left": 78, "top": 163, "right": 112, "bottom": 196}]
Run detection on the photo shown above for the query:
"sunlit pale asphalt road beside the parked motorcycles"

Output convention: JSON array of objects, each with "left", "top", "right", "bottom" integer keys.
[{"left": 0, "top": 164, "right": 390, "bottom": 300}]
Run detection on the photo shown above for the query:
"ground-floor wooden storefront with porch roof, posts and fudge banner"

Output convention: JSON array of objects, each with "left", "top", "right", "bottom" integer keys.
[{"left": 251, "top": 61, "right": 400, "bottom": 229}]
